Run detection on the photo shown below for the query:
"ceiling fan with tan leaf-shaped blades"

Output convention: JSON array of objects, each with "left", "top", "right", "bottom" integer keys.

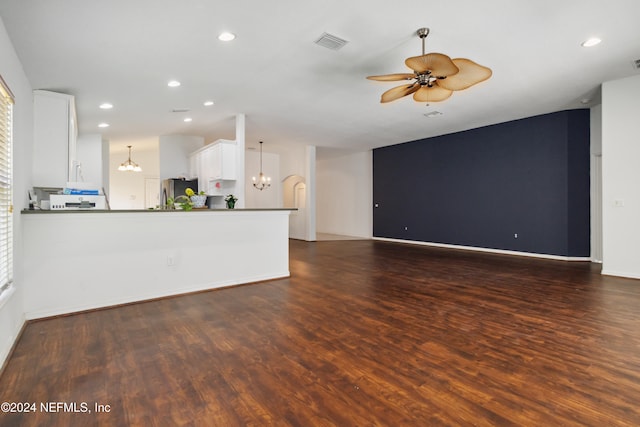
[{"left": 367, "top": 28, "right": 491, "bottom": 103}]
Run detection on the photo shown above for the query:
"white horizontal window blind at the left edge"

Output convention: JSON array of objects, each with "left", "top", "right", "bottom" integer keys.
[{"left": 0, "top": 76, "right": 13, "bottom": 294}]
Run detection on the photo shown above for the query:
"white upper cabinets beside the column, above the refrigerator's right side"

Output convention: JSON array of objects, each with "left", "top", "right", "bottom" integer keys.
[{"left": 190, "top": 139, "right": 237, "bottom": 196}]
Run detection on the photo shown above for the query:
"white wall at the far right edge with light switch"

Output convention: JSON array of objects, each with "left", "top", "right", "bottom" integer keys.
[{"left": 602, "top": 76, "right": 640, "bottom": 278}]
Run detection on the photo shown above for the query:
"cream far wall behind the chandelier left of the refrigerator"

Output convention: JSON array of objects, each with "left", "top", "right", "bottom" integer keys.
[{"left": 109, "top": 138, "right": 160, "bottom": 210}]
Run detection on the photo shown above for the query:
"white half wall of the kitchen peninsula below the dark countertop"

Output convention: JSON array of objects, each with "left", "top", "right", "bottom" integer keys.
[{"left": 22, "top": 209, "right": 291, "bottom": 319}]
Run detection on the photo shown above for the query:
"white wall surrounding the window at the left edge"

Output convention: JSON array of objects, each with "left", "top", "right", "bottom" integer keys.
[{"left": 0, "top": 18, "right": 33, "bottom": 366}]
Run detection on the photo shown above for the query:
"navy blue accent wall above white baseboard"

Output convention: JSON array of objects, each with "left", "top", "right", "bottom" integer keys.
[{"left": 373, "top": 110, "right": 590, "bottom": 257}]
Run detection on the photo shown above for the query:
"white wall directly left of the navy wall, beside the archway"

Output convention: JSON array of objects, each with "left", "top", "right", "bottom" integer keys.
[{"left": 316, "top": 150, "right": 373, "bottom": 238}]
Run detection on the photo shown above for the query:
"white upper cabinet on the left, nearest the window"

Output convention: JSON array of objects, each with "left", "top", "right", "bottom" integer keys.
[{"left": 33, "top": 90, "right": 78, "bottom": 187}]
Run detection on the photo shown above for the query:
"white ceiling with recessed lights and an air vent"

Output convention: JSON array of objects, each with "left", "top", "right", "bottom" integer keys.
[{"left": 0, "top": 0, "right": 640, "bottom": 151}]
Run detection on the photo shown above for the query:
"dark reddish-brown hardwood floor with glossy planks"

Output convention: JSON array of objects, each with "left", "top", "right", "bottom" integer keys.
[{"left": 0, "top": 241, "right": 640, "bottom": 427}]
